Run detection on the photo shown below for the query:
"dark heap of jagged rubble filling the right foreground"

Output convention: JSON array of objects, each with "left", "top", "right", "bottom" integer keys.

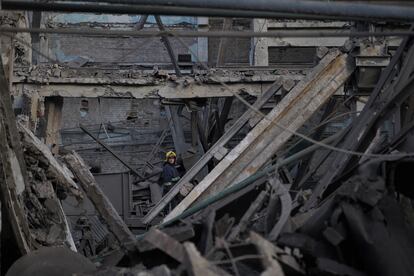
[{"left": 98, "top": 162, "right": 414, "bottom": 275}]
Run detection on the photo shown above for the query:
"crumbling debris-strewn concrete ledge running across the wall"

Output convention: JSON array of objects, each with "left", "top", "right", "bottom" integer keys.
[{"left": 14, "top": 63, "right": 304, "bottom": 85}]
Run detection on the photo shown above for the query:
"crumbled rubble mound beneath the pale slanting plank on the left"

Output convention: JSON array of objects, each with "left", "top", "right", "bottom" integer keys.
[{"left": 19, "top": 121, "right": 81, "bottom": 249}]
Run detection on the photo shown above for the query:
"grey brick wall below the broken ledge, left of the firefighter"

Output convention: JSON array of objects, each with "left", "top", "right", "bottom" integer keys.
[{"left": 60, "top": 98, "right": 167, "bottom": 172}]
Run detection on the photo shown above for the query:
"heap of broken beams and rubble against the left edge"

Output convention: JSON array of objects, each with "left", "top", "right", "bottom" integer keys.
[{"left": 0, "top": 52, "right": 81, "bottom": 269}]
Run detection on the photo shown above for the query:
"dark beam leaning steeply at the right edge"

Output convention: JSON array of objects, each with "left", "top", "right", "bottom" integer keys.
[{"left": 302, "top": 40, "right": 414, "bottom": 211}]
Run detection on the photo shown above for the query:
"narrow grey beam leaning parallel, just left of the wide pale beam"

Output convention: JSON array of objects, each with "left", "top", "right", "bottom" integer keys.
[{"left": 142, "top": 82, "right": 282, "bottom": 223}]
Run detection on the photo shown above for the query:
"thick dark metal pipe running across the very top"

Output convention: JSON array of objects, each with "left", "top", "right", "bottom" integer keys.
[{"left": 2, "top": 0, "right": 414, "bottom": 21}]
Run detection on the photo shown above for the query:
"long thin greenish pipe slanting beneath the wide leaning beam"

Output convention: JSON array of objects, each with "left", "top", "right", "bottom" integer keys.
[{"left": 160, "top": 132, "right": 341, "bottom": 227}]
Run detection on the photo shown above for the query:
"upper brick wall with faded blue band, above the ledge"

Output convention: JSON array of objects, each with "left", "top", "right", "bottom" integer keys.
[{"left": 43, "top": 13, "right": 197, "bottom": 66}]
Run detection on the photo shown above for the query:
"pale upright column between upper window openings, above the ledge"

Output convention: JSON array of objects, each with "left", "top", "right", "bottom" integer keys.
[{"left": 251, "top": 19, "right": 269, "bottom": 66}]
